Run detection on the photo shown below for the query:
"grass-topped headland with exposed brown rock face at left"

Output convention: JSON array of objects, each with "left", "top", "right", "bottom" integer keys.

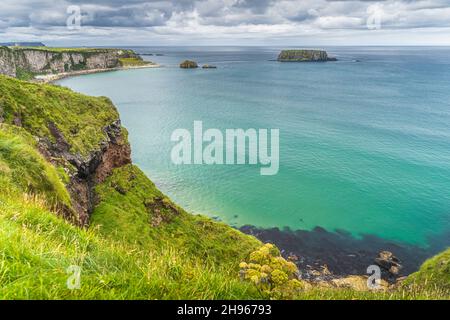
[{"left": 0, "top": 75, "right": 131, "bottom": 226}]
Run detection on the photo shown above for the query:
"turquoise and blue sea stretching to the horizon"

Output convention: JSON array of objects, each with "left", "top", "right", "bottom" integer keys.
[{"left": 59, "top": 47, "right": 450, "bottom": 247}]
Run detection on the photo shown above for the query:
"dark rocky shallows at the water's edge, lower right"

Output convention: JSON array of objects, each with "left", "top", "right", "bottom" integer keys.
[{"left": 236, "top": 225, "right": 449, "bottom": 282}]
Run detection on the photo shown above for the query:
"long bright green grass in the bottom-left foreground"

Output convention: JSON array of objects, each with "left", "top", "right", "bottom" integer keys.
[{"left": 0, "top": 194, "right": 258, "bottom": 299}]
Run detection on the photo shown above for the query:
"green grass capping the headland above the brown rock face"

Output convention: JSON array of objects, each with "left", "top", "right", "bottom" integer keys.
[{"left": 0, "top": 76, "right": 119, "bottom": 156}]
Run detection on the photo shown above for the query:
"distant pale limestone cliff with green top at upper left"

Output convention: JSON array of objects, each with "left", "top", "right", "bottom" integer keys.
[{"left": 0, "top": 47, "right": 140, "bottom": 77}]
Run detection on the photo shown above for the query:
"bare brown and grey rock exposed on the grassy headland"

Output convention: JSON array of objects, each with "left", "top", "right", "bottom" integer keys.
[{"left": 39, "top": 120, "right": 131, "bottom": 226}]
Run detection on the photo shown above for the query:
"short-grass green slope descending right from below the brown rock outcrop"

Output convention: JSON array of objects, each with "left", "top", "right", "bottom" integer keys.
[{"left": 91, "top": 165, "right": 261, "bottom": 266}]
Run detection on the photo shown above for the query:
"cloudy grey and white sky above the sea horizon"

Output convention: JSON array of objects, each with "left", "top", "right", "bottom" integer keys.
[{"left": 0, "top": 0, "right": 450, "bottom": 46}]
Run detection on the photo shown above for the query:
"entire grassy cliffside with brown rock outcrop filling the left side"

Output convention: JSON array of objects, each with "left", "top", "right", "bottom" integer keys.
[{"left": 0, "top": 76, "right": 260, "bottom": 299}]
